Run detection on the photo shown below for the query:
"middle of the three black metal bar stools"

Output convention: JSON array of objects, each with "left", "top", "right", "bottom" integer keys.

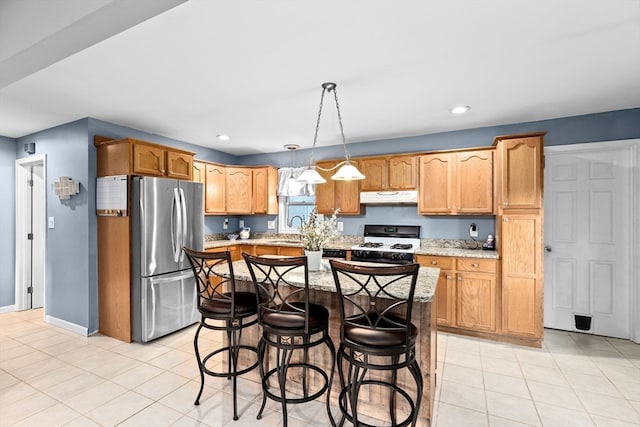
[{"left": 242, "top": 253, "right": 336, "bottom": 427}]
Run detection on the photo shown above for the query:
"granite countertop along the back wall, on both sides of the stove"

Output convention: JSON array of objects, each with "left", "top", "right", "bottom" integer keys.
[{"left": 204, "top": 236, "right": 500, "bottom": 259}]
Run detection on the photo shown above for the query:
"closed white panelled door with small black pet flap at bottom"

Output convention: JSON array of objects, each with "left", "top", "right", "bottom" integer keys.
[{"left": 544, "top": 143, "right": 633, "bottom": 338}]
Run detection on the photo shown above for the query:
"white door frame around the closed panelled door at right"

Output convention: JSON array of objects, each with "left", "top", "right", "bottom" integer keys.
[{"left": 544, "top": 138, "right": 640, "bottom": 343}]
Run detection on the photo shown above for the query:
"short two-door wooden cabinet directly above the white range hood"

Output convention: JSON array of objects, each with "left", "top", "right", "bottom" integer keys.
[{"left": 358, "top": 155, "right": 418, "bottom": 191}]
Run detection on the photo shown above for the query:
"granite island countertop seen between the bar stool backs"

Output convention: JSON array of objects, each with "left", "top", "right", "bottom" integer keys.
[{"left": 222, "top": 260, "right": 440, "bottom": 302}]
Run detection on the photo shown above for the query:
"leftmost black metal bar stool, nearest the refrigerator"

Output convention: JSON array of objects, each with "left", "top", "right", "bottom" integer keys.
[{"left": 183, "top": 248, "right": 258, "bottom": 420}]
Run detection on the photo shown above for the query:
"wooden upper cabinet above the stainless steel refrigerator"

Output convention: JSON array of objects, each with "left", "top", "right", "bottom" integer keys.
[{"left": 94, "top": 138, "right": 194, "bottom": 181}]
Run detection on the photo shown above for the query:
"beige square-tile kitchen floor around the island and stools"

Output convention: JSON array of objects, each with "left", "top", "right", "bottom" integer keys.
[{"left": 0, "top": 310, "right": 640, "bottom": 427}]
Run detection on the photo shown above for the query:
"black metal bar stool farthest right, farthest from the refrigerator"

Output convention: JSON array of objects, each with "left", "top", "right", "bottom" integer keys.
[{"left": 330, "top": 260, "right": 423, "bottom": 427}]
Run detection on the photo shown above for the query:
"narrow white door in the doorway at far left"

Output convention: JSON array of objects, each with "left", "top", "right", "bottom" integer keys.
[{"left": 15, "top": 155, "right": 46, "bottom": 310}]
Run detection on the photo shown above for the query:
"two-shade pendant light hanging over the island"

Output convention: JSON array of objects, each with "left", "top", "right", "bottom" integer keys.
[{"left": 297, "top": 82, "right": 364, "bottom": 184}]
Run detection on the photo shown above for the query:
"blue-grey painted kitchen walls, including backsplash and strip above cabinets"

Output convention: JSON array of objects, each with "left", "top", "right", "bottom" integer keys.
[{"left": 0, "top": 108, "right": 640, "bottom": 332}]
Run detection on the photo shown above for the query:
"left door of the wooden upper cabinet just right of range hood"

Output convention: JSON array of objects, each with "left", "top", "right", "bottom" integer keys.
[{"left": 418, "top": 153, "right": 452, "bottom": 214}]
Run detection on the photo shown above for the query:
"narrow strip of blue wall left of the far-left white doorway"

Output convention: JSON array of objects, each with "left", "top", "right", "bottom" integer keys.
[{"left": 0, "top": 136, "right": 16, "bottom": 308}]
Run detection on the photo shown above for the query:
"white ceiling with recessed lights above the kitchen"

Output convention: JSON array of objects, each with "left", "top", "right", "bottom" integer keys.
[{"left": 0, "top": 0, "right": 640, "bottom": 155}]
